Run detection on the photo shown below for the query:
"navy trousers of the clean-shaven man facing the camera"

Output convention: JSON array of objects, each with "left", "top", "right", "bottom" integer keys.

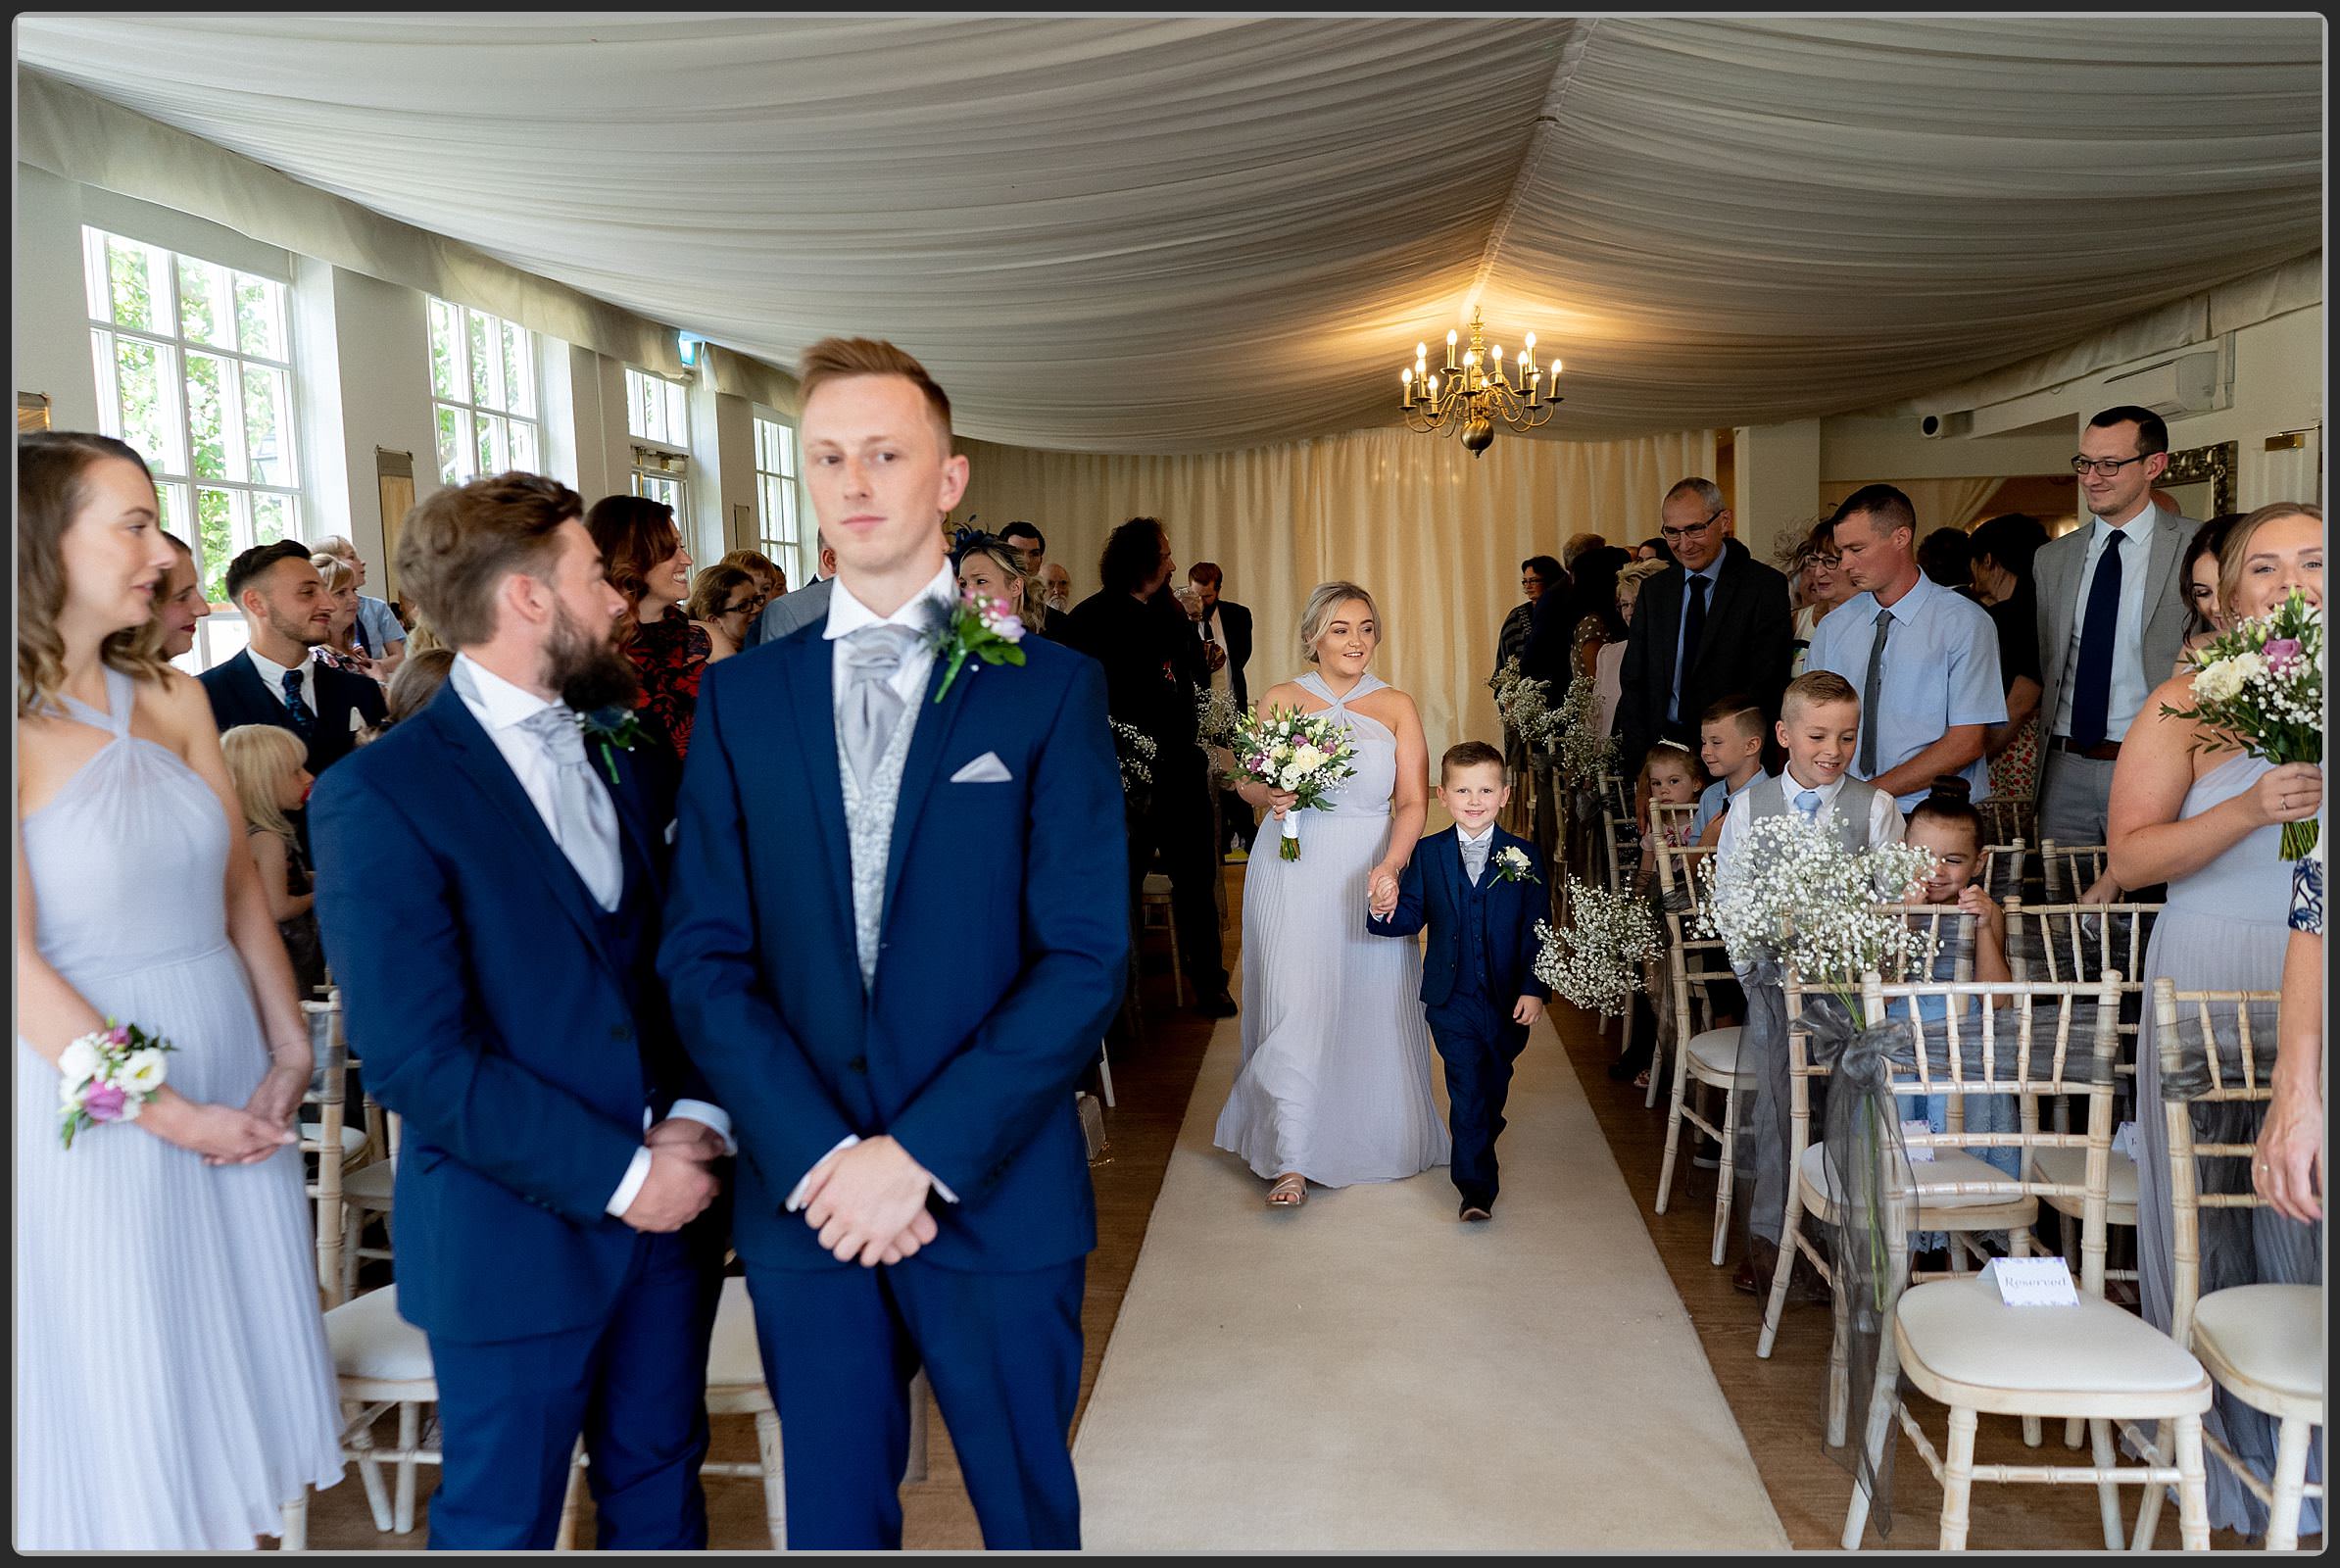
[{"left": 747, "top": 1256, "right": 1088, "bottom": 1551}]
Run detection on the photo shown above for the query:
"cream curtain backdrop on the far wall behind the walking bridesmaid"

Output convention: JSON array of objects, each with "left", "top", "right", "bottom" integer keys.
[{"left": 952, "top": 430, "right": 1715, "bottom": 763}]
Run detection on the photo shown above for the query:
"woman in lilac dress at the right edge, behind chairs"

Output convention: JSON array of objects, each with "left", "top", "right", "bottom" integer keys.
[{"left": 2106, "top": 506, "right": 2323, "bottom": 1536}]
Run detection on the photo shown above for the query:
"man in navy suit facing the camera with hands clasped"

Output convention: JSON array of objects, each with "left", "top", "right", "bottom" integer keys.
[{"left": 659, "top": 339, "right": 1130, "bottom": 1549}]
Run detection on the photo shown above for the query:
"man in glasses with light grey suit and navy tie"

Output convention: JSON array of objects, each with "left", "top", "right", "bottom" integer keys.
[{"left": 2033, "top": 405, "right": 2202, "bottom": 860}]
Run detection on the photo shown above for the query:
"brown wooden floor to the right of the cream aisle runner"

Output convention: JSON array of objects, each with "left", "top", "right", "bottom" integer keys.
[{"left": 1554, "top": 1004, "right": 2283, "bottom": 1551}]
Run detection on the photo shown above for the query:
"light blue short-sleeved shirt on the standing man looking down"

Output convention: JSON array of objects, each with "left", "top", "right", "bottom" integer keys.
[{"left": 1804, "top": 573, "right": 2008, "bottom": 812}]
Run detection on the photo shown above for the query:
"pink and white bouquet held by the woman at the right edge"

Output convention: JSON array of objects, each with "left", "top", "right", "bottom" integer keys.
[{"left": 2163, "top": 590, "right": 2323, "bottom": 861}]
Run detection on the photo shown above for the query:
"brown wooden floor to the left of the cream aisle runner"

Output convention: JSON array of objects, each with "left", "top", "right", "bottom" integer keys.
[{"left": 309, "top": 866, "right": 1243, "bottom": 1551}]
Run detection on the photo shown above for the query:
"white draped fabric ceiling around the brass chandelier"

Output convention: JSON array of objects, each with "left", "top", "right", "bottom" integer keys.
[{"left": 19, "top": 14, "right": 2321, "bottom": 454}]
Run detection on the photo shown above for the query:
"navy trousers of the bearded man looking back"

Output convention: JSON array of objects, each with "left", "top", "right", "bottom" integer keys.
[{"left": 430, "top": 1234, "right": 723, "bottom": 1551}]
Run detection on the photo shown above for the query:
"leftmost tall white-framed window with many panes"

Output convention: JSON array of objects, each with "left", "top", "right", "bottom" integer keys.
[{"left": 82, "top": 227, "right": 302, "bottom": 622}]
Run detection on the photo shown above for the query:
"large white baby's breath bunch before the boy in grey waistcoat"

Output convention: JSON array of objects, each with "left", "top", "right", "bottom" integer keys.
[{"left": 1699, "top": 809, "right": 1932, "bottom": 1015}]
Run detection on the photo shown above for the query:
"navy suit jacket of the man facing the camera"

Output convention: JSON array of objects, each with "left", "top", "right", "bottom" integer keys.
[{"left": 659, "top": 625, "right": 1130, "bottom": 1271}]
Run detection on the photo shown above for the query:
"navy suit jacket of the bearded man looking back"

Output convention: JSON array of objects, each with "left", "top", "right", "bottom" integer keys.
[{"left": 309, "top": 681, "right": 716, "bottom": 1344}]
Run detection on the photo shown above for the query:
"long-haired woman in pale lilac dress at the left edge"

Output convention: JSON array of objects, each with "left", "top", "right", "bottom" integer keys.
[{"left": 14, "top": 433, "right": 342, "bottom": 1551}]
